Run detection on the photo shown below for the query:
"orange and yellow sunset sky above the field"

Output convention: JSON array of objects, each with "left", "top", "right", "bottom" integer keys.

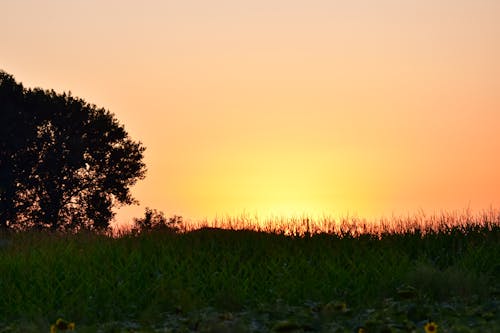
[{"left": 0, "top": 0, "right": 500, "bottom": 223}]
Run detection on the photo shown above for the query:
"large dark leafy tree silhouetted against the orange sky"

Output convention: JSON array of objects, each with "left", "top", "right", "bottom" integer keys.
[{"left": 0, "top": 72, "right": 146, "bottom": 230}]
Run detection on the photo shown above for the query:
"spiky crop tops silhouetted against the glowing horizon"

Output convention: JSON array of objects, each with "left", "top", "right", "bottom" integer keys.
[{"left": 179, "top": 209, "right": 500, "bottom": 237}]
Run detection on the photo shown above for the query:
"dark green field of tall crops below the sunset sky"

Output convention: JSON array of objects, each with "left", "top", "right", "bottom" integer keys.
[{"left": 0, "top": 214, "right": 500, "bottom": 333}]
